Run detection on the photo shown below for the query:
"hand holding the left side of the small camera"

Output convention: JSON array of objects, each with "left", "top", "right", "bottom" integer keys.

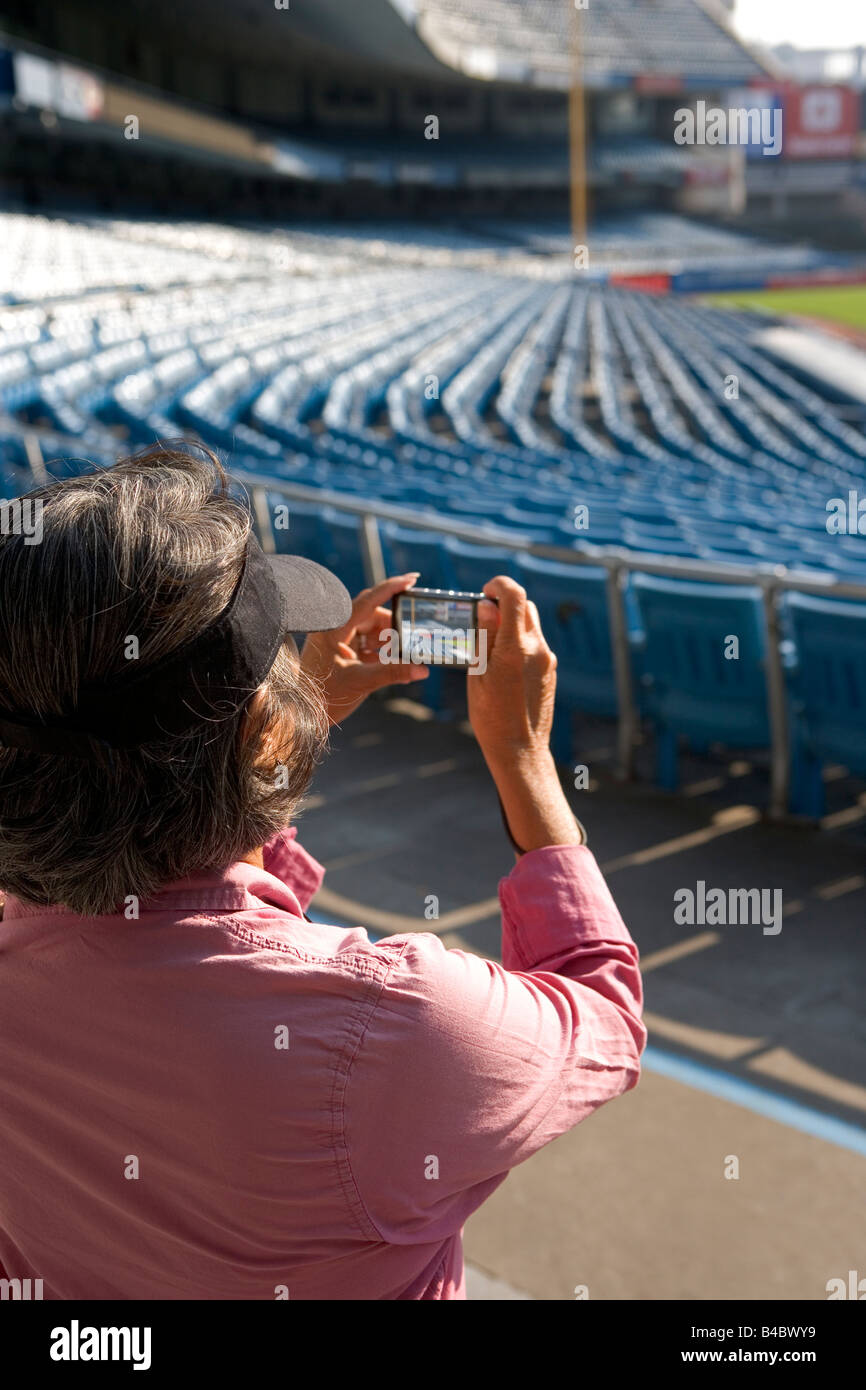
[{"left": 300, "top": 574, "right": 430, "bottom": 724}]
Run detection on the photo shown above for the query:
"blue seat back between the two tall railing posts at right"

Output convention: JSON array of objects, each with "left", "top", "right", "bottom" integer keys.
[{"left": 630, "top": 574, "right": 770, "bottom": 790}]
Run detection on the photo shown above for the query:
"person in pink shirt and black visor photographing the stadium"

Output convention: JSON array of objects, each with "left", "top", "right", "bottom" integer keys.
[{"left": 0, "top": 446, "right": 646, "bottom": 1300}]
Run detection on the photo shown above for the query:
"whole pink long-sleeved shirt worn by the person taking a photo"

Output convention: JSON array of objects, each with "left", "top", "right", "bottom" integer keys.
[{"left": 0, "top": 830, "right": 646, "bottom": 1300}]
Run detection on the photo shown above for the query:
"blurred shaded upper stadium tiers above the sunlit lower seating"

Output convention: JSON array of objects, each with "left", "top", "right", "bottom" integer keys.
[{"left": 0, "top": 0, "right": 800, "bottom": 217}]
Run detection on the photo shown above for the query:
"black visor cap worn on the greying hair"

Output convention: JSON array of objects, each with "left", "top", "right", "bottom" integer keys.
[{"left": 0, "top": 532, "right": 352, "bottom": 760}]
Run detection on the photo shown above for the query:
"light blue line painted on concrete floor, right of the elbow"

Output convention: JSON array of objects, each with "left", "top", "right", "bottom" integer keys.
[{"left": 642, "top": 1044, "right": 866, "bottom": 1158}]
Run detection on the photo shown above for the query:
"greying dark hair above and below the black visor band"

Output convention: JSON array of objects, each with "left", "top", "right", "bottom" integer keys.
[{"left": 0, "top": 445, "right": 328, "bottom": 916}]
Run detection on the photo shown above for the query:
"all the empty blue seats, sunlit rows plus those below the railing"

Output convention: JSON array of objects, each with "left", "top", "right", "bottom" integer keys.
[{"left": 0, "top": 215, "right": 866, "bottom": 812}]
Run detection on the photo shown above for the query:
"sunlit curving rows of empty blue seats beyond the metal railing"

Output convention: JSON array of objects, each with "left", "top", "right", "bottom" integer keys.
[{"left": 0, "top": 209, "right": 866, "bottom": 577}]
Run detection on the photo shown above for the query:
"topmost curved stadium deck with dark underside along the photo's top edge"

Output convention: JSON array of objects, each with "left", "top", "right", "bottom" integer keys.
[{"left": 6, "top": 0, "right": 765, "bottom": 88}]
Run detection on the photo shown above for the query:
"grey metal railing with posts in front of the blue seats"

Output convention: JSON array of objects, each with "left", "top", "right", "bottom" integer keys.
[{"left": 232, "top": 470, "right": 866, "bottom": 819}]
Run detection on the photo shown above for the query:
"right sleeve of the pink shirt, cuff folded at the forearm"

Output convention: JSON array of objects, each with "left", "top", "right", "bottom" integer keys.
[{"left": 343, "top": 845, "right": 646, "bottom": 1244}]
